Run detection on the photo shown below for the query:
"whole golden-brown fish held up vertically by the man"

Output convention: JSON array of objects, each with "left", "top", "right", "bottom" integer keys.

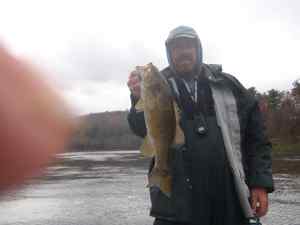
[{"left": 136, "top": 63, "right": 176, "bottom": 196}]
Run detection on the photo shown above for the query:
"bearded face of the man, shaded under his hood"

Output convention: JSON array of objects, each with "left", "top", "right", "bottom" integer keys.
[{"left": 170, "top": 38, "right": 197, "bottom": 73}]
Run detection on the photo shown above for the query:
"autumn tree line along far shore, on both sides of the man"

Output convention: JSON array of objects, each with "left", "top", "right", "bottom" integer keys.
[{"left": 69, "top": 80, "right": 300, "bottom": 152}]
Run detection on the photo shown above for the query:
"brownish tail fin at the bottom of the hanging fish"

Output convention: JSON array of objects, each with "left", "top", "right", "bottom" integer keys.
[{"left": 148, "top": 168, "right": 172, "bottom": 198}]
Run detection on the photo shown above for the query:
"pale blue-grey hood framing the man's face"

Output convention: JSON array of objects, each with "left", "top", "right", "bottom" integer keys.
[{"left": 166, "top": 26, "right": 203, "bottom": 72}]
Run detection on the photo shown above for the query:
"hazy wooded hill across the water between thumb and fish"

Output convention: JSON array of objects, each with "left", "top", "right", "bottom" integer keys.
[{"left": 69, "top": 111, "right": 141, "bottom": 151}]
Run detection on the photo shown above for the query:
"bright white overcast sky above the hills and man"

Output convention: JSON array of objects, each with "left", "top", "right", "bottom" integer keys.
[{"left": 0, "top": 0, "right": 300, "bottom": 114}]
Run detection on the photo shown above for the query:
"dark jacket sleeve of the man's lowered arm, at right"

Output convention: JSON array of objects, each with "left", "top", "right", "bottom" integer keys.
[{"left": 246, "top": 101, "right": 274, "bottom": 193}]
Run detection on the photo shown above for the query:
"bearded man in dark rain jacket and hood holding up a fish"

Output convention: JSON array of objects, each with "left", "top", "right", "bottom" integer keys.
[{"left": 128, "top": 26, "right": 274, "bottom": 225}]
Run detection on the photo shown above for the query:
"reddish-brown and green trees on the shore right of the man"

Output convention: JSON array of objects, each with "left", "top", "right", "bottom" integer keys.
[{"left": 248, "top": 80, "right": 300, "bottom": 147}]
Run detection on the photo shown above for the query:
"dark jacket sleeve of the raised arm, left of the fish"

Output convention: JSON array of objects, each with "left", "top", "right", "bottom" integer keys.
[{"left": 127, "top": 95, "right": 147, "bottom": 138}]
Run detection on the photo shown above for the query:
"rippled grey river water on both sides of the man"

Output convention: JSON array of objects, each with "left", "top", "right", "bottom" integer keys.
[{"left": 0, "top": 151, "right": 300, "bottom": 225}]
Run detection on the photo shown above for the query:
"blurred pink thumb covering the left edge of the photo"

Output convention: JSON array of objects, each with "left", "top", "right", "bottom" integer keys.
[{"left": 0, "top": 47, "right": 73, "bottom": 194}]
